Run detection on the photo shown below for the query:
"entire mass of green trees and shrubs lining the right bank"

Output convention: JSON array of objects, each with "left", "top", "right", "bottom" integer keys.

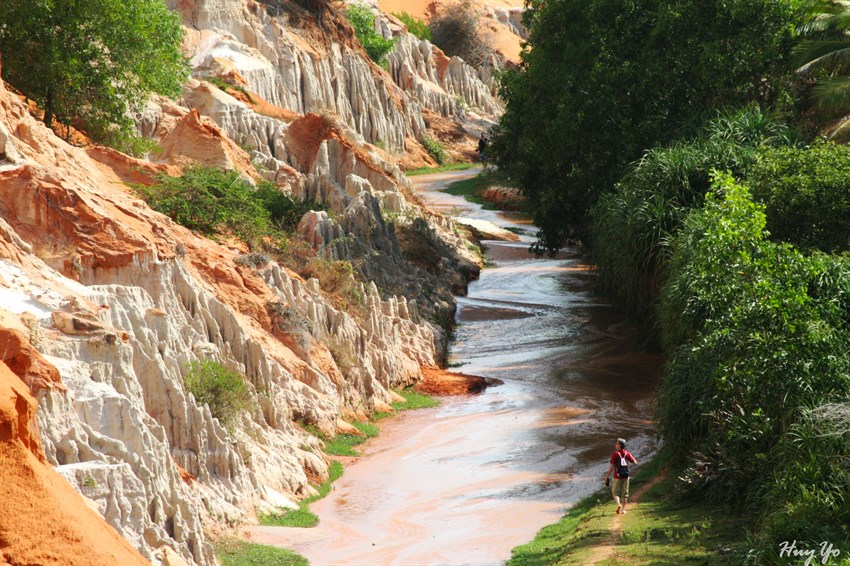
[{"left": 504, "top": 0, "right": 850, "bottom": 563}]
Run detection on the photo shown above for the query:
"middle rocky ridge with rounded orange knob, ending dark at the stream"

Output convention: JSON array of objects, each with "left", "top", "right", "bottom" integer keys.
[{"left": 171, "top": 81, "right": 480, "bottom": 320}]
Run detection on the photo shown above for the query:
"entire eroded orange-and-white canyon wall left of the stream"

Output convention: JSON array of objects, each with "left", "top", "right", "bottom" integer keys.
[{"left": 0, "top": 0, "right": 500, "bottom": 564}]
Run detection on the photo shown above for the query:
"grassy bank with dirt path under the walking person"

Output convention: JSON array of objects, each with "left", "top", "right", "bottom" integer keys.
[{"left": 508, "top": 456, "right": 751, "bottom": 566}]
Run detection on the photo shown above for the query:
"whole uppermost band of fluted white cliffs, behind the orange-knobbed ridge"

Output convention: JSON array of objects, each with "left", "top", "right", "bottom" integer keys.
[{"left": 170, "top": 0, "right": 501, "bottom": 163}]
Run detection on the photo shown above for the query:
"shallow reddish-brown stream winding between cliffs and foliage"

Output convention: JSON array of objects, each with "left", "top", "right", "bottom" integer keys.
[{"left": 252, "top": 172, "right": 660, "bottom": 565}]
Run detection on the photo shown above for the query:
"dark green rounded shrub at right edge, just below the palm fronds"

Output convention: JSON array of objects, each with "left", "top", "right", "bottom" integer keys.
[{"left": 748, "top": 142, "right": 850, "bottom": 252}]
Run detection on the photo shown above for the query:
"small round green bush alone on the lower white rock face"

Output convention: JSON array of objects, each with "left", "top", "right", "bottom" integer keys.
[{"left": 183, "top": 360, "right": 251, "bottom": 428}]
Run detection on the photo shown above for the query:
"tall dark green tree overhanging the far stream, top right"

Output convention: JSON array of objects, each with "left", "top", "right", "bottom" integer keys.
[{"left": 492, "top": 0, "right": 796, "bottom": 250}]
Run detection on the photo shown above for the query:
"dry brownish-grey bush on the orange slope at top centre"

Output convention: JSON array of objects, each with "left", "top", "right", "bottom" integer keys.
[{"left": 430, "top": 0, "right": 493, "bottom": 67}]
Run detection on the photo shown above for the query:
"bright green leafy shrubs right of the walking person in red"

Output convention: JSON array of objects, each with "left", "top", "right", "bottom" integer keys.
[{"left": 658, "top": 175, "right": 850, "bottom": 547}]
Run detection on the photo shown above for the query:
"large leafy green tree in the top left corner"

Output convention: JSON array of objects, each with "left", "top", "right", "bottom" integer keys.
[{"left": 0, "top": 0, "right": 187, "bottom": 137}]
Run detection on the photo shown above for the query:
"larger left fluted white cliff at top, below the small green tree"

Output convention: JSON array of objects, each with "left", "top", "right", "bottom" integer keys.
[{"left": 168, "top": 0, "right": 425, "bottom": 152}]
